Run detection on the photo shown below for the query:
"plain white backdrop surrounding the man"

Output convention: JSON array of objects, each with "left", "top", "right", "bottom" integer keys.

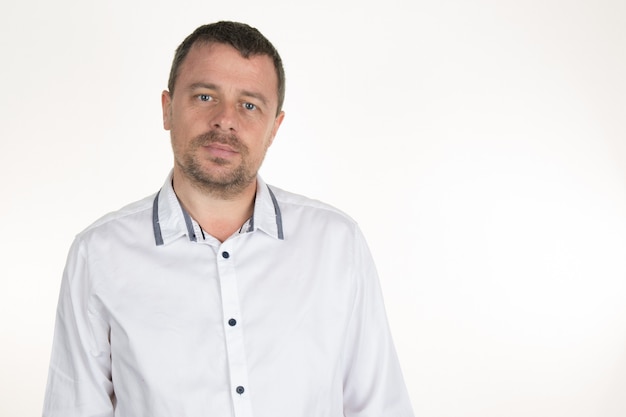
[{"left": 0, "top": 0, "right": 626, "bottom": 417}]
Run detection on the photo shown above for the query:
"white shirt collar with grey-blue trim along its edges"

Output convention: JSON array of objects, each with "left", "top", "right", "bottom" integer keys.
[{"left": 152, "top": 172, "right": 284, "bottom": 246}]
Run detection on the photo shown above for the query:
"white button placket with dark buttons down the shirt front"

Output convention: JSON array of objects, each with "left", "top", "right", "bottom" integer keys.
[{"left": 217, "top": 241, "right": 252, "bottom": 417}]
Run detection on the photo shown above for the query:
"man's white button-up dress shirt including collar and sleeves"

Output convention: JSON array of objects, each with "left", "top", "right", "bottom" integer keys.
[{"left": 43, "top": 174, "right": 413, "bottom": 417}]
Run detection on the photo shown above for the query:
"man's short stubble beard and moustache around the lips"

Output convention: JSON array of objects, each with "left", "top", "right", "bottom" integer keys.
[{"left": 176, "top": 131, "right": 258, "bottom": 199}]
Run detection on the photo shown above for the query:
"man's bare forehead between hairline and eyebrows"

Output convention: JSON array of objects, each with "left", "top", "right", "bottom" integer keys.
[{"left": 176, "top": 42, "right": 278, "bottom": 95}]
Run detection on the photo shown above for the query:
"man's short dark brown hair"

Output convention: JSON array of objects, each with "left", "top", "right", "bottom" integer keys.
[{"left": 167, "top": 22, "right": 285, "bottom": 114}]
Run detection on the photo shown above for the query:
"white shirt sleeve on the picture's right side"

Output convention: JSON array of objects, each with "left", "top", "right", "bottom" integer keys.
[{"left": 343, "top": 229, "right": 413, "bottom": 417}]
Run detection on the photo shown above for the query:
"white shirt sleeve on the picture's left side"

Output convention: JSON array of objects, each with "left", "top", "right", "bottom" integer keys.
[{"left": 43, "top": 239, "right": 115, "bottom": 417}]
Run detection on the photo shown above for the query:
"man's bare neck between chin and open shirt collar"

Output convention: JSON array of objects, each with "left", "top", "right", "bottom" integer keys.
[{"left": 173, "top": 170, "right": 256, "bottom": 242}]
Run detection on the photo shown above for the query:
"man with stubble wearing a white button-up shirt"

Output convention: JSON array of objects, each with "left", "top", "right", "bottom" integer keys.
[{"left": 43, "top": 22, "right": 413, "bottom": 417}]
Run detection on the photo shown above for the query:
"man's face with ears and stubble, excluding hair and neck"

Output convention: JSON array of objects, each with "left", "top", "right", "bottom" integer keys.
[{"left": 162, "top": 43, "right": 284, "bottom": 195}]
